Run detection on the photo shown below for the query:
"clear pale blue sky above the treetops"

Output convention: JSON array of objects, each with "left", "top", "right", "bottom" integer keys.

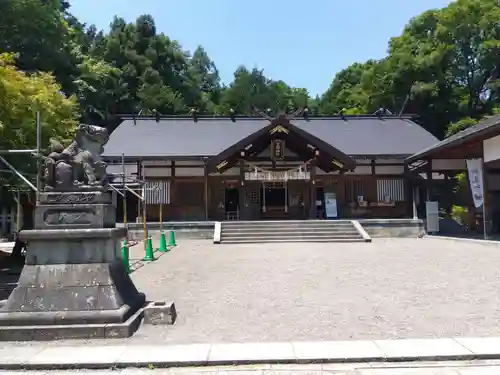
[{"left": 71, "top": 0, "right": 450, "bottom": 95}]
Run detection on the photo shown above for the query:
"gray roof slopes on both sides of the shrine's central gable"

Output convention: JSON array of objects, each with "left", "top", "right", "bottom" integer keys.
[{"left": 103, "top": 117, "right": 438, "bottom": 158}]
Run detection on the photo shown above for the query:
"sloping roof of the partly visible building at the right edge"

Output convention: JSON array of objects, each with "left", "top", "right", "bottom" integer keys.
[{"left": 406, "top": 115, "right": 500, "bottom": 163}]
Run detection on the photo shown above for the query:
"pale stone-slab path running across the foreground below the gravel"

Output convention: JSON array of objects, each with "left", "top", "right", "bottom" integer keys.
[{"left": 0, "top": 337, "right": 500, "bottom": 370}]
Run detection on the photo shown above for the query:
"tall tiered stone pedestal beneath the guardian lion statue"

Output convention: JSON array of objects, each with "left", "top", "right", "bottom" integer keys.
[{"left": 0, "top": 191, "right": 145, "bottom": 340}]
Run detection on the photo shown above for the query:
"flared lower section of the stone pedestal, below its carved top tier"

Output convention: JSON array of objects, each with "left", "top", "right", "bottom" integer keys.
[{"left": 0, "top": 228, "right": 145, "bottom": 332}]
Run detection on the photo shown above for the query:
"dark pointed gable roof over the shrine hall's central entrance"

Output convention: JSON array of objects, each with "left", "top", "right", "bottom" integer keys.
[{"left": 207, "top": 116, "right": 356, "bottom": 172}]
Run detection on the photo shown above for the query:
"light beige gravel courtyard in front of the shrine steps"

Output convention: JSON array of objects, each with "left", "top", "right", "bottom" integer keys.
[{"left": 123, "top": 238, "right": 500, "bottom": 344}]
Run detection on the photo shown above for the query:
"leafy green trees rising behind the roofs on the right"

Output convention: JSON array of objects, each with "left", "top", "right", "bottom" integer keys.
[{"left": 321, "top": 0, "right": 500, "bottom": 137}]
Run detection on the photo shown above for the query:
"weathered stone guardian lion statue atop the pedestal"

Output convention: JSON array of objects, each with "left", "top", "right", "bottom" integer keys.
[{"left": 43, "top": 124, "right": 109, "bottom": 191}]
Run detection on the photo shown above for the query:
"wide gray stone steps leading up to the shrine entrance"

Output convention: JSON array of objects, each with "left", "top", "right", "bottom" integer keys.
[{"left": 219, "top": 220, "right": 371, "bottom": 243}]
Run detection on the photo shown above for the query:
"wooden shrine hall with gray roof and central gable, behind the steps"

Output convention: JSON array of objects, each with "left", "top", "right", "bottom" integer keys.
[{"left": 103, "top": 116, "right": 438, "bottom": 221}]
